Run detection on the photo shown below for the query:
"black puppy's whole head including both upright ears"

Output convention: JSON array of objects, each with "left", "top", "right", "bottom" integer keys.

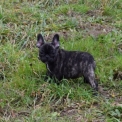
[{"left": 36, "top": 34, "right": 59, "bottom": 63}]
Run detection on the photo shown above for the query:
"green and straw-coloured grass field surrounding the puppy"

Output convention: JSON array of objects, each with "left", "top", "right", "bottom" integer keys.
[{"left": 0, "top": 0, "right": 122, "bottom": 122}]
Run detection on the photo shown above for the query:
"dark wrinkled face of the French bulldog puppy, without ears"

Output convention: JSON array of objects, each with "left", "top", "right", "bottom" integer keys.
[{"left": 39, "top": 43, "right": 57, "bottom": 63}]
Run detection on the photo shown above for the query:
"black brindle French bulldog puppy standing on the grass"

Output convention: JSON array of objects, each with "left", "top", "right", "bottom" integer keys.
[{"left": 36, "top": 34, "right": 98, "bottom": 90}]
